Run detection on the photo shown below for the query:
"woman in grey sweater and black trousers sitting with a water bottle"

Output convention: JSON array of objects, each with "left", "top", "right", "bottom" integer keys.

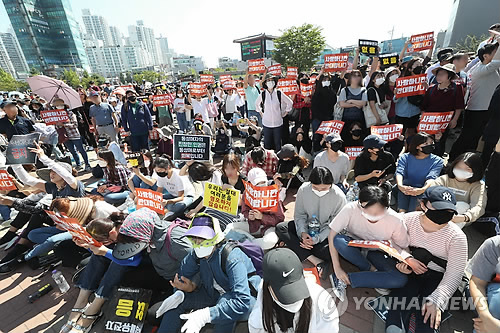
[{"left": 276, "top": 167, "right": 347, "bottom": 279}]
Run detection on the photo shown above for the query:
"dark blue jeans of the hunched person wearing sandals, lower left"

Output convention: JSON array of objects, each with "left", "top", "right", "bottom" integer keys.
[{"left": 77, "top": 254, "right": 132, "bottom": 299}]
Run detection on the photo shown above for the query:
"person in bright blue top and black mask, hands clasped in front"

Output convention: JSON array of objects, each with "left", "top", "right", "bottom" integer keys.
[{"left": 396, "top": 132, "right": 443, "bottom": 212}]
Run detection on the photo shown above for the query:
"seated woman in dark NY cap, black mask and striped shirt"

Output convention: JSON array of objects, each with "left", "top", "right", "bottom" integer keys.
[{"left": 385, "top": 186, "right": 468, "bottom": 333}]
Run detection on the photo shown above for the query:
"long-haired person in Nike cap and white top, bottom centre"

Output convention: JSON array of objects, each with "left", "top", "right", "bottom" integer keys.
[{"left": 248, "top": 248, "right": 339, "bottom": 333}]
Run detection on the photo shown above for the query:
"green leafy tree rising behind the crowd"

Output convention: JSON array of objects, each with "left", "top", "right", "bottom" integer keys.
[{"left": 273, "top": 23, "right": 325, "bottom": 71}]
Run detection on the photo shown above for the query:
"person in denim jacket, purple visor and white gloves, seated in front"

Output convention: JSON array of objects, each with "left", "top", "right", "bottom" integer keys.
[{"left": 156, "top": 214, "right": 261, "bottom": 333}]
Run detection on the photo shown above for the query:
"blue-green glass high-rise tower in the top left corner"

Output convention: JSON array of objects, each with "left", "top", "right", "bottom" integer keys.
[{"left": 3, "top": 0, "right": 90, "bottom": 72}]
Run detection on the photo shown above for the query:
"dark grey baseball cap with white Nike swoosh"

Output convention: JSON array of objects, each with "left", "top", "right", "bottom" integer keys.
[{"left": 262, "top": 248, "right": 310, "bottom": 305}]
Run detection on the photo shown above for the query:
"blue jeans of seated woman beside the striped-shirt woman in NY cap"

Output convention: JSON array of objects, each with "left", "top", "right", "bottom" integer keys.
[{"left": 333, "top": 234, "right": 408, "bottom": 289}]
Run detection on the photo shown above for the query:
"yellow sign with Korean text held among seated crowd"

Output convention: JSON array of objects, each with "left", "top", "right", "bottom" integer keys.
[{"left": 203, "top": 182, "right": 240, "bottom": 216}]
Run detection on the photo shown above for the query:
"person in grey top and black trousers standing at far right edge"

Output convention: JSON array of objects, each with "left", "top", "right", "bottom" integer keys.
[{"left": 450, "top": 40, "right": 500, "bottom": 160}]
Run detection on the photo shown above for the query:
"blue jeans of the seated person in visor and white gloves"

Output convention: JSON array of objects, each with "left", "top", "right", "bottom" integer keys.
[{"left": 157, "top": 287, "right": 255, "bottom": 333}]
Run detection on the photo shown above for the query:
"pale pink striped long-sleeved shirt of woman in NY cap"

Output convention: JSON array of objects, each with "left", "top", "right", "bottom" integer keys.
[{"left": 403, "top": 212, "right": 468, "bottom": 311}]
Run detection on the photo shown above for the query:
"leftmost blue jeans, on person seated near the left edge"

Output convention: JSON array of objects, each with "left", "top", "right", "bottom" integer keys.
[{"left": 24, "top": 227, "right": 71, "bottom": 260}]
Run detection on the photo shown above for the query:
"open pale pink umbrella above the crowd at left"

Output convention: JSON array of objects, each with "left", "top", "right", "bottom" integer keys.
[{"left": 26, "top": 75, "right": 82, "bottom": 109}]
